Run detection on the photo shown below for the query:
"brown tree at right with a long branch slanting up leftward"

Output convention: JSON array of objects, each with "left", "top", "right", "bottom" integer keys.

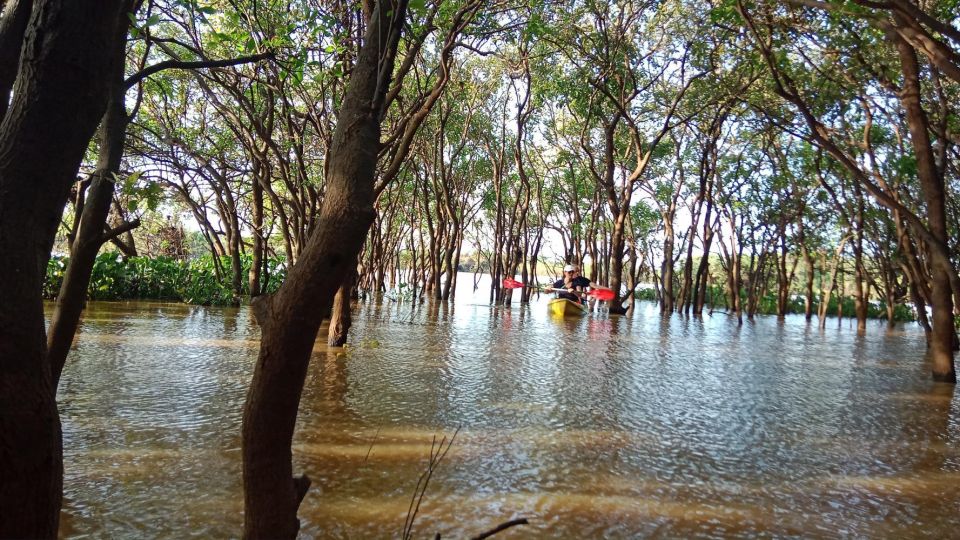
[{"left": 736, "top": 0, "right": 960, "bottom": 382}]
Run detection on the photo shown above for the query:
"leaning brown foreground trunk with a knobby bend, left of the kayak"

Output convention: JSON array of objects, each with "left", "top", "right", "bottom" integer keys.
[{"left": 242, "top": 0, "right": 407, "bottom": 539}]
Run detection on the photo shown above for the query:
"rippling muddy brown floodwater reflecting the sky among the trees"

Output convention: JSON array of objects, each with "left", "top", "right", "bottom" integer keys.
[{"left": 59, "top": 291, "right": 960, "bottom": 538}]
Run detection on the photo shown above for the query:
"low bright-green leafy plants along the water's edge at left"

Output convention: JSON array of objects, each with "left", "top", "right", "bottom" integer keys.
[{"left": 43, "top": 253, "right": 286, "bottom": 305}]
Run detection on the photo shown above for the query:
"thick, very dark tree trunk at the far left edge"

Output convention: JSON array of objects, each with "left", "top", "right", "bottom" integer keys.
[{"left": 0, "top": 0, "right": 121, "bottom": 538}]
